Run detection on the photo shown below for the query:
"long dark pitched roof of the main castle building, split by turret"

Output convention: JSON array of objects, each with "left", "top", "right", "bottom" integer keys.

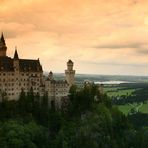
[{"left": 0, "top": 56, "right": 42, "bottom": 72}]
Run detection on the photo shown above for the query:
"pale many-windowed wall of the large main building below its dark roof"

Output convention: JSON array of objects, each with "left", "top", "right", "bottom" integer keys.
[{"left": 0, "top": 72, "right": 42, "bottom": 100}]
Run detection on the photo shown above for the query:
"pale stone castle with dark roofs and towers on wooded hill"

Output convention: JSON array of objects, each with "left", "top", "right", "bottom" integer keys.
[{"left": 0, "top": 33, "right": 75, "bottom": 108}]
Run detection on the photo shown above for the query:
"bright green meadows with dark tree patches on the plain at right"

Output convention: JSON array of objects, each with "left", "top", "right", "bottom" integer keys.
[{"left": 104, "top": 83, "right": 148, "bottom": 115}]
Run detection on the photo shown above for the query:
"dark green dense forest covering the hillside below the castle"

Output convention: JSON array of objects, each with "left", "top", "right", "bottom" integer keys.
[{"left": 0, "top": 84, "right": 148, "bottom": 148}]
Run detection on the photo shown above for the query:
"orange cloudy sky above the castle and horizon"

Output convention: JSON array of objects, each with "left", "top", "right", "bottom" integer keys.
[{"left": 0, "top": 0, "right": 148, "bottom": 76}]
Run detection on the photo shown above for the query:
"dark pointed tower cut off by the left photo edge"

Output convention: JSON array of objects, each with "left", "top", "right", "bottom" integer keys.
[{"left": 0, "top": 33, "right": 7, "bottom": 57}]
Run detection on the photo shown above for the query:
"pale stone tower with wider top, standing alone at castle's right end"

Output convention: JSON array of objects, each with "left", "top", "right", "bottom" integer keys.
[{"left": 65, "top": 60, "right": 75, "bottom": 87}]
